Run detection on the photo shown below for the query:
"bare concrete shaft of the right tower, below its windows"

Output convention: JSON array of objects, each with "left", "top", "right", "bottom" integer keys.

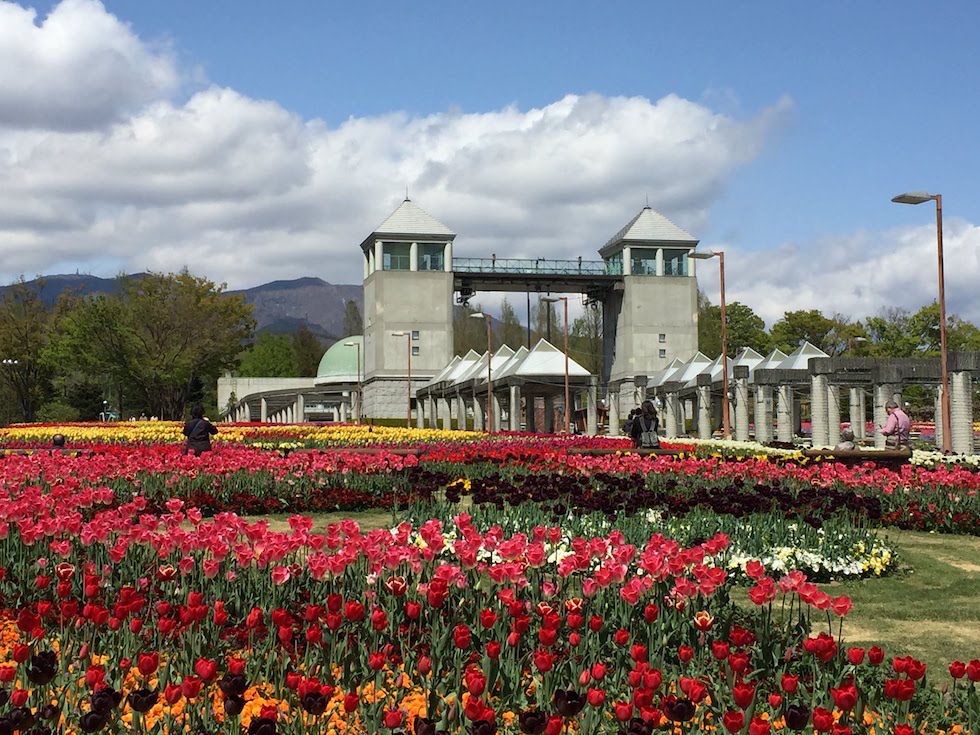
[{"left": 603, "top": 276, "right": 698, "bottom": 381}]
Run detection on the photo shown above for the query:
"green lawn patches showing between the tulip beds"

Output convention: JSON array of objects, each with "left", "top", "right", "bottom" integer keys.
[{"left": 250, "top": 511, "right": 980, "bottom": 683}]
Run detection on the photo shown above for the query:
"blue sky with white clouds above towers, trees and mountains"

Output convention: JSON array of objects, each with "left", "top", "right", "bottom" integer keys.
[{"left": 0, "top": 0, "right": 980, "bottom": 324}]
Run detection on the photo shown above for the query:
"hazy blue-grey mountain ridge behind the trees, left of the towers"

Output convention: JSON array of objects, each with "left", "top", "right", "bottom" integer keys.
[{"left": 0, "top": 273, "right": 364, "bottom": 341}]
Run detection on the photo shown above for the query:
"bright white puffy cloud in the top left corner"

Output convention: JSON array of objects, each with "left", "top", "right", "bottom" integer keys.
[{"left": 0, "top": 0, "right": 179, "bottom": 130}]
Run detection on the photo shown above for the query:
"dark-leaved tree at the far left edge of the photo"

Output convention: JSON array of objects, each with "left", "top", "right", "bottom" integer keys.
[{"left": 0, "top": 279, "right": 54, "bottom": 421}]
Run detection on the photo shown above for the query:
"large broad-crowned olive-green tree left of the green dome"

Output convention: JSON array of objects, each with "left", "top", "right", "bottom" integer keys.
[{"left": 54, "top": 270, "right": 255, "bottom": 419}]
